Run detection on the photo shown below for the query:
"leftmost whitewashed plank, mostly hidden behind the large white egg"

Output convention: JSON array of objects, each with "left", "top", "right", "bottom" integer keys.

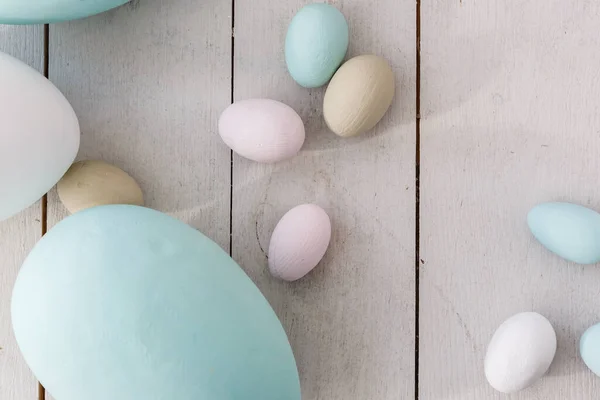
[{"left": 0, "top": 25, "right": 44, "bottom": 400}]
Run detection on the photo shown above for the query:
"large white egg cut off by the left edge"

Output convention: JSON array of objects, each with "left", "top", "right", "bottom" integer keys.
[{"left": 0, "top": 53, "right": 80, "bottom": 221}]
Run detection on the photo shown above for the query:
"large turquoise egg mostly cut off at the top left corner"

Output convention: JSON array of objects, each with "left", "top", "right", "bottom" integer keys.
[{"left": 0, "top": 0, "right": 129, "bottom": 24}]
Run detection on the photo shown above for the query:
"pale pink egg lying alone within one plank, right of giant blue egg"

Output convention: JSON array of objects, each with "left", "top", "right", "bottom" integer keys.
[{"left": 269, "top": 204, "right": 331, "bottom": 281}]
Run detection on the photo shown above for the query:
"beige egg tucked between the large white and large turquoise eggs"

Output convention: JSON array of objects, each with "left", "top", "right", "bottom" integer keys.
[{"left": 57, "top": 161, "right": 144, "bottom": 214}]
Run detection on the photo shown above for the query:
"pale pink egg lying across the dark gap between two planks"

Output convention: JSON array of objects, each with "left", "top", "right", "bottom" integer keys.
[{"left": 219, "top": 99, "right": 305, "bottom": 163}]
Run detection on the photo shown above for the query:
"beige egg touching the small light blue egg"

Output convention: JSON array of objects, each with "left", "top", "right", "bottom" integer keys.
[{"left": 323, "top": 55, "right": 395, "bottom": 137}]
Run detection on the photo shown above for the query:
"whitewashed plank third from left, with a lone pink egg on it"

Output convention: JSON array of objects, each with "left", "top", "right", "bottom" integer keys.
[{"left": 233, "top": 0, "right": 415, "bottom": 400}]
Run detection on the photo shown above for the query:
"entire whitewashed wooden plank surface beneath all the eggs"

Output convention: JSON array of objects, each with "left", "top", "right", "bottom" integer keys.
[{"left": 0, "top": 0, "right": 600, "bottom": 400}]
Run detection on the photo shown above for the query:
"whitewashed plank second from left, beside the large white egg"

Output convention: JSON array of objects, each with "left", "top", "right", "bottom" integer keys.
[{"left": 48, "top": 0, "right": 231, "bottom": 400}]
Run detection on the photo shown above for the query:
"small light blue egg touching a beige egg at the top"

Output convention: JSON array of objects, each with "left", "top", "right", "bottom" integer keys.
[{"left": 285, "top": 3, "right": 348, "bottom": 88}]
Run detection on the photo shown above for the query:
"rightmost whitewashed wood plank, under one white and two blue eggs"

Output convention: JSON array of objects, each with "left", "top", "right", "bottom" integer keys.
[{"left": 419, "top": 0, "right": 600, "bottom": 400}]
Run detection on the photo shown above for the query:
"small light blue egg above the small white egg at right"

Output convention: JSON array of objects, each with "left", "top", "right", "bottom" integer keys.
[{"left": 527, "top": 203, "right": 600, "bottom": 264}]
